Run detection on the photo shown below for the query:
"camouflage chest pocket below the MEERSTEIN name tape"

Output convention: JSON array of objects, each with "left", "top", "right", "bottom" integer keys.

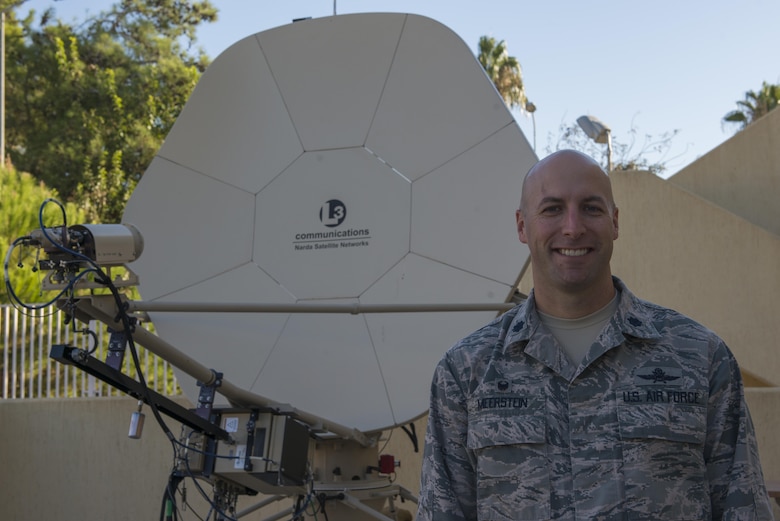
[{"left": 467, "top": 397, "right": 550, "bottom": 521}]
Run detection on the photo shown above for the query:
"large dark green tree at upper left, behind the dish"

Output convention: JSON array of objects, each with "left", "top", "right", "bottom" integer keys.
[{"left": 6, "top": 0, "right": 216, "bottom": 222}]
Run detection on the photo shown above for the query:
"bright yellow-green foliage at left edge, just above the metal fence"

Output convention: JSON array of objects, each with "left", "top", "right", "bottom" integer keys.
[{"left": 0, "top": 167, "right": 84, "bottom": 304}]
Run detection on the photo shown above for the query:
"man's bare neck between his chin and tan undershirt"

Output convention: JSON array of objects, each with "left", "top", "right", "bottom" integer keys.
[{"left": 534, "top": 277, "right": 615, "bottom": 319}]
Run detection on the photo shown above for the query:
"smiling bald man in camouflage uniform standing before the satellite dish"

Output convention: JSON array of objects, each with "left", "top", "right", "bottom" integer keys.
[{"left": 417, "top": 150, "right": 772, "bottom": 521}]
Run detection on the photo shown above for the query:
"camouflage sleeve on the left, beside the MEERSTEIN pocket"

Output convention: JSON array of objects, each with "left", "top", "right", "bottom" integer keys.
[{"left": 417, "top": 357, "right": 477, "bottom": 521}]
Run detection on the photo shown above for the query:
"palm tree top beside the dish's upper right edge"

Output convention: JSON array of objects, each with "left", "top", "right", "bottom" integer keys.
[{"left": 477, "top": 36, "right": 528, "bottom": 112}]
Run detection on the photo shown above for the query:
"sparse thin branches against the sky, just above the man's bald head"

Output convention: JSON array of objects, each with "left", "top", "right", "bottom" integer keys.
[{"left": 547, "top": 117, "right": 679, "bottom": 175}]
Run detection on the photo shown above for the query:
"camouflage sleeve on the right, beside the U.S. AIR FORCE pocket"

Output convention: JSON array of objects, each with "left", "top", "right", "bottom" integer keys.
[{"left": 704, "top": 341, "right": 773, "bottom": 521}]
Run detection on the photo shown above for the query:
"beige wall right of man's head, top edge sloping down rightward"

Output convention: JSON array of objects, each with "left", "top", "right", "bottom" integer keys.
[{"left": 612, "top": 172, "right": 780, "bottom": 385}]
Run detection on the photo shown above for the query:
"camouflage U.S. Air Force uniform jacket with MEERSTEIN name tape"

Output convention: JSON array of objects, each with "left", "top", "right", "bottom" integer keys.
[{"left": 417, "top": 278, "right": 772, "bottom": 521}]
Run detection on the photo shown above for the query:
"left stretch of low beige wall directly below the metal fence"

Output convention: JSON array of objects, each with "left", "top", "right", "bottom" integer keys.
[{"left": 0, "top": 398, "right": 179, "bottom": 521}]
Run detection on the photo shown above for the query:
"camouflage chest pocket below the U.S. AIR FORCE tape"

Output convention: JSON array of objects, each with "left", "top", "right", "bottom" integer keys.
[{"left": 618, "top": 393, "right": 710, "bottom": 520}]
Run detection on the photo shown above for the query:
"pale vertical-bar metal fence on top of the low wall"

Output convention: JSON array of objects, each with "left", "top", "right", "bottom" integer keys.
[{"left": 0, "top": 305, "right": 181, "bottom": 399}]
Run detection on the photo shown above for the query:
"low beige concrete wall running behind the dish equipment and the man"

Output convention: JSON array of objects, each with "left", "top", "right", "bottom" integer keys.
[{"left": 0, "top": 389, "right": 780, "bottom": 521}]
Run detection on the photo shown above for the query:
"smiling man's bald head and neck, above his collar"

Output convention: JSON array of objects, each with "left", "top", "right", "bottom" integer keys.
[{"left": 516, "top": 150, "right": 618, "bottom": 318}]
